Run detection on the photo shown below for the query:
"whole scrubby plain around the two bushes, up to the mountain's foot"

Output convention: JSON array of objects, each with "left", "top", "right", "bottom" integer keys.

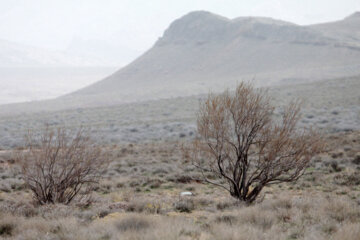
[{"left": 0, "top": 78, "right": 360, "bottom": 240}]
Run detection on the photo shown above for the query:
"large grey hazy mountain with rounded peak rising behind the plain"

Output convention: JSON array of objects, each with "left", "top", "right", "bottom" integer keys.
[{"left": 65, "top": 11, "right": 360, "bottom": 104}]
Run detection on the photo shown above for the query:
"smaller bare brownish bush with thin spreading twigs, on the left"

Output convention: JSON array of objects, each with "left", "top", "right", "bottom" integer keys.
[{"left": 17, "top": 128, "right": 108, "bottom": 204}]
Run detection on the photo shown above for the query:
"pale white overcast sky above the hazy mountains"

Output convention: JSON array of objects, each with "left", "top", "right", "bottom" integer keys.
[{"left": 0, "top": 0, "right": 360, "bottom": 51}]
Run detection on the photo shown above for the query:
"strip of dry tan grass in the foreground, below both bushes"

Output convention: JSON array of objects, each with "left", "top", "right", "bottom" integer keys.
[{"left": 0, "top": 195, "right": 360, "bottom": 240}]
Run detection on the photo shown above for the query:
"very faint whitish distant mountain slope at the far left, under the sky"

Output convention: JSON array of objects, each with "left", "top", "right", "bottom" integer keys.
[{"left": 0, "top": 39, "right": 107, "bottom": 68}]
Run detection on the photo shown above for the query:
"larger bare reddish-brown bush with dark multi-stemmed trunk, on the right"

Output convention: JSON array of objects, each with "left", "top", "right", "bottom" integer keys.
[{"left": 185, "top": 83, "right": 323, "bottom": 203}]
